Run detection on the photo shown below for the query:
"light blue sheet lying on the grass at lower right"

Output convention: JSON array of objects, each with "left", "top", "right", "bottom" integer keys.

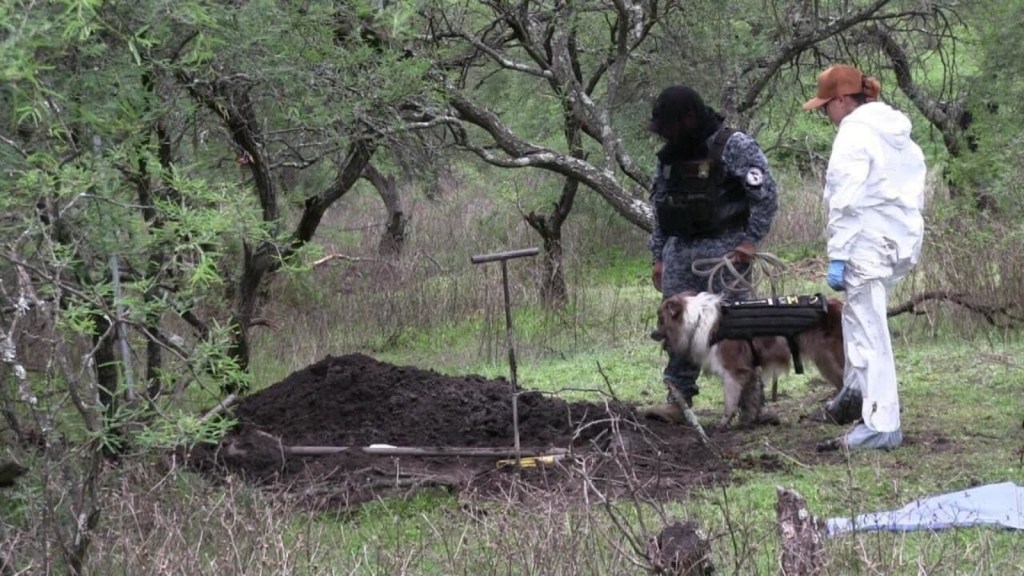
[{"left": 826, "top": 482, "right": 1024, "bottom": 536}]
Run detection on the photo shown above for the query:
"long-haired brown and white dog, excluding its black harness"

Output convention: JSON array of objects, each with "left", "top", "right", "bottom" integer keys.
[{"left": 651, "top": 292, "right": 845, "bottom": 427}]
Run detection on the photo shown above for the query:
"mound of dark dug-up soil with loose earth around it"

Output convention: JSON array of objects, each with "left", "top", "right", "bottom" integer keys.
[{"left": 190, "top": 354, "right": 839, "bottom": 505}]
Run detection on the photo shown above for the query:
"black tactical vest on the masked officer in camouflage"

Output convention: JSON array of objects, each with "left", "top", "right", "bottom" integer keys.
[{"left": 654, "top": 128, "right": 751, "bottom": 238}]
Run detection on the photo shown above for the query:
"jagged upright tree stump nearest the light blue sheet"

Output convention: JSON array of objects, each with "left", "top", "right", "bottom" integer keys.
[{"left": 775, "top": 486, "right": 826, "bottom": 576}]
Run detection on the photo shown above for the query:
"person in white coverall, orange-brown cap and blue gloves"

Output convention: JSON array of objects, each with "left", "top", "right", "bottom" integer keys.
[{"left": 804, "top": 65, "right": 927, "bottom": 450}]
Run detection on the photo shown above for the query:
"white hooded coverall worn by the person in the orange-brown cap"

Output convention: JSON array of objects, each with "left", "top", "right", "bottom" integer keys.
[{"left": 824, "top": 101, "right": 926, "bottom": 433}]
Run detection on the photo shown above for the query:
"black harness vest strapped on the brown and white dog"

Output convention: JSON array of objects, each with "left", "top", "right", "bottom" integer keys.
[{"left": 711, "top": 294, "right": 828, "bottom": 374}]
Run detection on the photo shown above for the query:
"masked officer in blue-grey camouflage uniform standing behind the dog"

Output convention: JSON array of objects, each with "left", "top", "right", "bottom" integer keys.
[{"left": 644, "top": 86, "right": 778, "bottom": 421}]
